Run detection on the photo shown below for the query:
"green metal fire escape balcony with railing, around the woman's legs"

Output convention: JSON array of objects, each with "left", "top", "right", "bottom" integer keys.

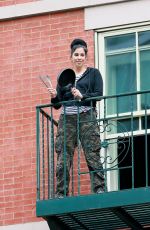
[{"left": 36, "top": 91, "right": 150, "bottom": 230}]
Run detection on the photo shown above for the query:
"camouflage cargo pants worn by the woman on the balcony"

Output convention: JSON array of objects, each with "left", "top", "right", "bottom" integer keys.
[{"left": 55, "top": 110, "right": 104, "bottom": 195}]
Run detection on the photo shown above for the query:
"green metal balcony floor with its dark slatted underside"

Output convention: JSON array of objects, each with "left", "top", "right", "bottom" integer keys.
[{"left": 37, "top": 188, "right": 150, "bottom": 230}]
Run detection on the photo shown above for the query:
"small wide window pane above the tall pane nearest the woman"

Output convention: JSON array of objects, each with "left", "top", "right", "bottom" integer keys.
[{"left": 105, "top": 34, "right": 135, "bottom": 52}]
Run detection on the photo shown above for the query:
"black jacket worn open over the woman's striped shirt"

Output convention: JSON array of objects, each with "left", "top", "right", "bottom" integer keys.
[{"left": 51, "top": 67, "right": 103, "bottom": 109}]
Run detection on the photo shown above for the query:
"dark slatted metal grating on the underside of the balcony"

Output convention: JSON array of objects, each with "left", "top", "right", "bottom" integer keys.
[{"left": 49, "top": 204, "right": 150, "bottom": 230}]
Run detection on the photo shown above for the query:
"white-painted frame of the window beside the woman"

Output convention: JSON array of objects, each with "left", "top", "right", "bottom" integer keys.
[{"left": 95, "top": 23, "right": 150, "bottom": 191}]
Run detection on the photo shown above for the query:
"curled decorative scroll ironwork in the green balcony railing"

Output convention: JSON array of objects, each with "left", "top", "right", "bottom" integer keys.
[{"left": 82, "top": 120, "right": 130, "bottom": 169}]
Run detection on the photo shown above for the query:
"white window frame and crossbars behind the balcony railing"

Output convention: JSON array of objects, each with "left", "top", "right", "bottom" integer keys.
[{"left": 95, "top": 23, "right": 150, "bottom": 191}]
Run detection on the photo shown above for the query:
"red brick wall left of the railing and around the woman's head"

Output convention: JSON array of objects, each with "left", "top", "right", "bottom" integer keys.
[{"left": 0, "top": 9, "right": 94, "bottom": 226}]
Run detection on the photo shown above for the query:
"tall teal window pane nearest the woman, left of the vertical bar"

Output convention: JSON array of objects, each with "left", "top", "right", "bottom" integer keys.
[{"left": 106, "top": 52, "right": 136, "bottom": 114}]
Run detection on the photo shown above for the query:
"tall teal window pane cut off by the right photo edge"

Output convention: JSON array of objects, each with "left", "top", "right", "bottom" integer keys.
[{"left": 140, "top": 50, "right": 150, "bottom": 109}]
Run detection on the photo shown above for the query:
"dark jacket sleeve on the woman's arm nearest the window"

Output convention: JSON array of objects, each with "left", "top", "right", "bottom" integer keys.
[{"left": 82, "top": 68, "right": 103, "bottom": 99}]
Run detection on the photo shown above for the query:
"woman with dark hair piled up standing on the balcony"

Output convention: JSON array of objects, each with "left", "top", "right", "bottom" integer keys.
[{"left": 49, "top": 38, "right": 104, "bottom": 197}]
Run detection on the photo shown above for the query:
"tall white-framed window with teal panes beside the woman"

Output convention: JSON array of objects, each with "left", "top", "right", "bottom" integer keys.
[{"left": 97, "top": 26, "right": 150, "bottom": 190}]
